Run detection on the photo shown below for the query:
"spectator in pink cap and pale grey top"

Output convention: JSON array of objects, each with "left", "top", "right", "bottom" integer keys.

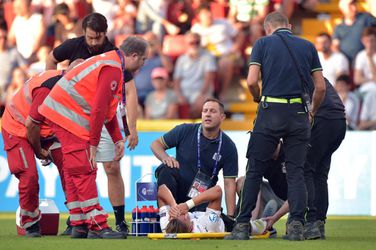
[{"left": 145, "top": 68, "right": 178, "bottom": 119}]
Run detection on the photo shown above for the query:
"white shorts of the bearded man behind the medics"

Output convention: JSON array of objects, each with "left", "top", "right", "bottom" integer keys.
[{"left": 96, "top": 126, "right": 115, "bottom": 162}]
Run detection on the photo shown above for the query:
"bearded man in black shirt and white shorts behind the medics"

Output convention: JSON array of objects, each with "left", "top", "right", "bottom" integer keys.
[{"left": 46, "top": 13, "right": 131, "bottom": 235}]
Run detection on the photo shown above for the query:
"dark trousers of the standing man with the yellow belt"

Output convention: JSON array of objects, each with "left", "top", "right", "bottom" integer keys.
[{"left": 236, "top": 103, "right": 310, "bottom": 223}]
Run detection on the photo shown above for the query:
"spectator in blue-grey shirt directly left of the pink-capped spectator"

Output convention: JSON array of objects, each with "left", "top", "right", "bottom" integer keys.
[{"left": 134, "top": 32, "right": 174, "bottom": 107}]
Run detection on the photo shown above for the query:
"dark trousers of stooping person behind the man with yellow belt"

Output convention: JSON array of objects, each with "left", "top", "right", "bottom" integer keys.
[{"left": 304, "top": 118, "right": 346, "bottom": 222}]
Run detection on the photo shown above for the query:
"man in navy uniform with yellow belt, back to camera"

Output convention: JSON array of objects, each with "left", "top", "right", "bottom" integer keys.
[{"left": 225, "top": 12, "right": 325, "bottom": 240}]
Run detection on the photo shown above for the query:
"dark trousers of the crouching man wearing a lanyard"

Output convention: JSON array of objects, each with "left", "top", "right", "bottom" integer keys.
[{"left": 155, "top": 164, "right": 208, "bottom": 212}]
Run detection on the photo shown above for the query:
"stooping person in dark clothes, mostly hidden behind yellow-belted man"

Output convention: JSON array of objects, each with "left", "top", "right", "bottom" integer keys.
[{"left": 265, "top": 79, "right": 346, "bottom": 239}]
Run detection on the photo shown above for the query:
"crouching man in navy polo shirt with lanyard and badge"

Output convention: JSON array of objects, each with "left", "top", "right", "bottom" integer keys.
[{"left": 151, "top": 99, "right": 238, "bottom": 216}]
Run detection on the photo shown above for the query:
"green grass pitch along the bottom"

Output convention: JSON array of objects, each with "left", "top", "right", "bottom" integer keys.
[{"left": 0, "top": 213, "right": 376, "bottom": 250}]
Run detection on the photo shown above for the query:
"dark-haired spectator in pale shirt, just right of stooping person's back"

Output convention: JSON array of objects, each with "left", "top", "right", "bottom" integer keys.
[{"left": 334, "top": 75, "right": 360, "bottom": 130}]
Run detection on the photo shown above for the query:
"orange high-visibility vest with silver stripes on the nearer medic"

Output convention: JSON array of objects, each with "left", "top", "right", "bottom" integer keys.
[{"left": 39, "top": 51, "right": 123, "bottom": 140}]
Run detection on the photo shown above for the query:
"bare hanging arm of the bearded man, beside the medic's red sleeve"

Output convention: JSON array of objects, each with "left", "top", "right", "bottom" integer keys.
[{"left": 125, "top": 80, "right": 138, "bottom": 150}]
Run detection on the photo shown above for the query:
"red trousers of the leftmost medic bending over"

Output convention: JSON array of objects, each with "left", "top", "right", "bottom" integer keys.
[{"left": 2, "top": 129, "right": 40, "bottom": 228}]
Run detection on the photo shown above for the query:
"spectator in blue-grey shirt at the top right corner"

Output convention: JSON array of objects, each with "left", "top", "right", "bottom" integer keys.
[{"left": 333, "top": 0, "right": 376, "bottom": 63}]
